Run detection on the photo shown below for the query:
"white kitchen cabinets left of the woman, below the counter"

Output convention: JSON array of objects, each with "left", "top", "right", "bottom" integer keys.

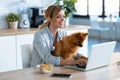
[{"left": 0, "top": 34, "right": 34, "bottom": 72}]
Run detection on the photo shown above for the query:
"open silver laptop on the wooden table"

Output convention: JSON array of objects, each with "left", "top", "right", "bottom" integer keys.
[{"left": 65, "top": 41, "right": 116, "bottom": 71}]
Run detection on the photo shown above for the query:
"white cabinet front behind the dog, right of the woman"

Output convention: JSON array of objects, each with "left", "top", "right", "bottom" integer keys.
[{"left": 65, "top": 29, "right": 88, "bottom": 56}]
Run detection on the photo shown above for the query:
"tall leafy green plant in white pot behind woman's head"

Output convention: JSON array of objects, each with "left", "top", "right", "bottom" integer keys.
[{"left": 55, "top": 0, "right": 77, "bottom": 25}]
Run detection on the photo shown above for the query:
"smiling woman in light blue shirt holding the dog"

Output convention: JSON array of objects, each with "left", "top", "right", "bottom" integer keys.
[{"left": 31, "top": 5, "right": 87, "bottom": 66}]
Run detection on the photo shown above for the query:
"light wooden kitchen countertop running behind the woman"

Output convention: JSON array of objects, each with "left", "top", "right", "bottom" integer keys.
[{"left": 0, "top": 25, "right": 89, "bottom": 36}]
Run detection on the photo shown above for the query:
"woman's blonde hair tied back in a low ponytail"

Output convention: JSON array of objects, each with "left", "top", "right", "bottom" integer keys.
[{"left": 39, "top": 5, "right": 64, "bottom": 29}]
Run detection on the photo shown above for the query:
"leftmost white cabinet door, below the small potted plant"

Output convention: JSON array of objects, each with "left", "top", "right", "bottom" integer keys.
[{"left": 0, "top": 36, "right": 16, "bottom": 72}]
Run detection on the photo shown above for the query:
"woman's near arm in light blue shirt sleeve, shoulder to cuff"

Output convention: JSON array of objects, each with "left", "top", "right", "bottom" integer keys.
[{"left": 33, "top": 32, "right": 60, "bottom": 65}]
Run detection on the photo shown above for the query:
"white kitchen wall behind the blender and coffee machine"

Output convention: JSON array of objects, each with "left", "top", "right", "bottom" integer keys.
[{"left": 0, "top": 0, "right": 56, "bottom": 28}]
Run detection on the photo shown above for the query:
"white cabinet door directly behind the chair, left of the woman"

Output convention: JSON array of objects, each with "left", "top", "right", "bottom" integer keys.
[{"left": 16, "top": 34, "right": 34, "bottom": 69}]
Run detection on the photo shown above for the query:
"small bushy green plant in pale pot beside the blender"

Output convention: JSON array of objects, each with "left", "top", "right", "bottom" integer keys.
[{"left": 6, "top": 13, "right": 20, "bottom": 29}]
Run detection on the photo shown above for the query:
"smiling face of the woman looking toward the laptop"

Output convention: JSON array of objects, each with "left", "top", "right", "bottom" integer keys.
[{"left": 50, "top": 10, "right": 65, "bottom": 28}]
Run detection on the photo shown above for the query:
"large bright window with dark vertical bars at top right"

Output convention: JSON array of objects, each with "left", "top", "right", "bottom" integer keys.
[{"left": 74, "top": 0, "right": 120, "bottom": 17}]
